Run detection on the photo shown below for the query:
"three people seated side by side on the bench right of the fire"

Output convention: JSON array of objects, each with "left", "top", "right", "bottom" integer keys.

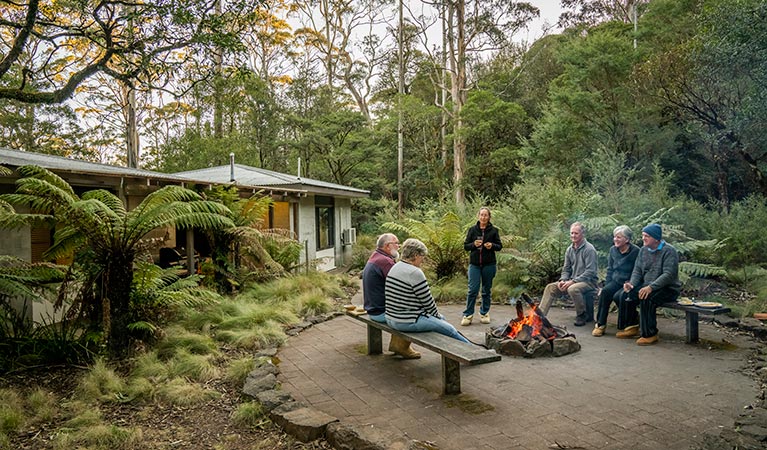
[{"left": 540, "top": 222, "right": 682, "bottom": 345}]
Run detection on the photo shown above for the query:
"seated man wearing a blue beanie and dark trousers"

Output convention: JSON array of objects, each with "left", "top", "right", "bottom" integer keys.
[{"left": 615, "top": 223, "right": 682, "bottom": 345}]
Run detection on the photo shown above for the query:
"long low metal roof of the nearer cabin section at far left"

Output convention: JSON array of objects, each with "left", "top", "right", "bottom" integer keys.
[{"left": 0, "top": 148, "right": 189, "bottom": 183}]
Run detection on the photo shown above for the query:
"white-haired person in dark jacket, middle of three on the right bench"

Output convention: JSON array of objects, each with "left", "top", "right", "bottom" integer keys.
[{"left": 591, "top": 225, "right": 639, "bottom": 336}]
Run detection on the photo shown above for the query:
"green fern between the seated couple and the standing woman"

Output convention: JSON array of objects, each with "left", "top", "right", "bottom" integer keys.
[{"left": 383, "top": 212, "right": 466, "bottom": 279}]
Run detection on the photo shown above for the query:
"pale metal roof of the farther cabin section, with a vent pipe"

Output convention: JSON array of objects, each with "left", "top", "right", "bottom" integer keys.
[{"left": 174, "top": 164, "right": 370, "bottom": 197}]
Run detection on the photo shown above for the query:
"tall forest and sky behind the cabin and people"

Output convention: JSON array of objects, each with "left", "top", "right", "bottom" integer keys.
[{"left": 0, "top": 0, "right": 767, "bottom": 310}]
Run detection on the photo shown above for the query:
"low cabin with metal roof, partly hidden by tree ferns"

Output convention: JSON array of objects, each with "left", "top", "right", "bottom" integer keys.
[{"left": 0, "top": 148, "right": 369, "bottom": 322}]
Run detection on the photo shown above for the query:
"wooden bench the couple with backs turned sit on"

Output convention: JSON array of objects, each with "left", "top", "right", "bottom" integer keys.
[{"left": 347, "top": 312, "right": 501, "bottom": 395}]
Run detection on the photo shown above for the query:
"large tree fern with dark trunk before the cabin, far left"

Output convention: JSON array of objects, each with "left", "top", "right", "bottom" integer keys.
[{"left": 0, "top": 166, "right": 234, "bottom": 354}]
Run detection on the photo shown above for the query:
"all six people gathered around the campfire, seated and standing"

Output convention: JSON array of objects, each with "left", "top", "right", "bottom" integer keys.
[{"left": 362, "top": 207, "right": 681, "bottom": 359}]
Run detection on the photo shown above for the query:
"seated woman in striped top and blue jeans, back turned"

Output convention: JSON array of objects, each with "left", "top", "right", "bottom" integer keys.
[{"left": 386, "top": 238, "right": 469, "bottom": 342}]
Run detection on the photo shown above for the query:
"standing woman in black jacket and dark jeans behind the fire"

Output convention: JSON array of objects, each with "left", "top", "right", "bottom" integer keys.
[{"left": 461, "top": 206, "right": 503, "bottom": 326}]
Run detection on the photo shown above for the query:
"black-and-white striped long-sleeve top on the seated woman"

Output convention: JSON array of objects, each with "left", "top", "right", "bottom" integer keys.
[{"left": 386, "top": 261, "right": 439, "bottom": 323}]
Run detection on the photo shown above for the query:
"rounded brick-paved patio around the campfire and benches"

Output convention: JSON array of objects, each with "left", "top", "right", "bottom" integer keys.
[{"left": 278, "top": 297, "right": 758, "bottom": 450}]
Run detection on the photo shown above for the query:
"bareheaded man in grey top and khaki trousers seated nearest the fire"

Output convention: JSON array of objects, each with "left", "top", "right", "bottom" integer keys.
[{"left": 541, "top": 222, "right": 597, "bottom": 327}]
